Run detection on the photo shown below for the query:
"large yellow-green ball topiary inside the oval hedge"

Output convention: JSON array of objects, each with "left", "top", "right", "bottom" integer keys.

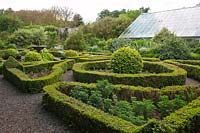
[{"left": 111, "top": 47, "right": 143, "bottom": 74}]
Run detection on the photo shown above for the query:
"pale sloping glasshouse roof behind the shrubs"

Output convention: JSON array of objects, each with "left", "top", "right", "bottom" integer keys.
[{"left": 120, "top": 6, "right": 200, "bottom": 38}]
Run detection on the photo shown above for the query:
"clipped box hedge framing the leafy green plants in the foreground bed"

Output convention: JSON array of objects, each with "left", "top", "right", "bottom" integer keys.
[{"left": 43, "top": 82, "right": 200, "bottom": 133}]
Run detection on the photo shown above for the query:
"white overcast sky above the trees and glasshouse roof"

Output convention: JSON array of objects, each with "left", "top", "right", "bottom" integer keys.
[{"left": 0, "top": 0, "right": 200, "bottom": 22}]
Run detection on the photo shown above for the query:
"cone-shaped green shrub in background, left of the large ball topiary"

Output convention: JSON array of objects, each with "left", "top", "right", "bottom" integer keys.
[{"left": 64, "top": 31, "right": 86, "bottom": 51}]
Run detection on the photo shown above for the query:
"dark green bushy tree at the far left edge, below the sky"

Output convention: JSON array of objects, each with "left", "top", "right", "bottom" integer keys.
[{"left": 0, "top": 15, "right": 22, "bottom": 32}]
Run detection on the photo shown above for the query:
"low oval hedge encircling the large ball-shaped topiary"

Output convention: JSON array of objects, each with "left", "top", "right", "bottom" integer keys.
[{"left": 72, "top": 61, "right": 187, "bottom": 88}]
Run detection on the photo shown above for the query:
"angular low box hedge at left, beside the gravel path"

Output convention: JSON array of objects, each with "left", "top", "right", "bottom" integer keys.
[{"left": 3, "top": 57, "right": 74, "bottom": 93}]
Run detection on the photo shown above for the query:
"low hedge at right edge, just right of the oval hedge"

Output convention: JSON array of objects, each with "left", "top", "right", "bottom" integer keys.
[{"left": 165, "top": 60, "right": 200, "bottom": 81}]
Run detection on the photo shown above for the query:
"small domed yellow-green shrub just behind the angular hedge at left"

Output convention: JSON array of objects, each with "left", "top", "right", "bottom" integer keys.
[{"left": 24, "top": 51, "right": 42, "bottom": 62}]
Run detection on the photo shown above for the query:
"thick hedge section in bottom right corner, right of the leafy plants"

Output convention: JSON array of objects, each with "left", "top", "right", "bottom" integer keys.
[{"left": 156, "top": 97, "right": 200, "bottom": 133}]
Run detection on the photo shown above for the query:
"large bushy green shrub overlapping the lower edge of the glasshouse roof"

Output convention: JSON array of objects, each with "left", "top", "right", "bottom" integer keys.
[{"left": 154, "top": 29, "right": 190, "bottom": 59}]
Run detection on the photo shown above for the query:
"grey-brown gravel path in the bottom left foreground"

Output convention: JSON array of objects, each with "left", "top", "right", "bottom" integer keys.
[{"left": 0, "top": 76, "right": 78, "bottom": 133}]
